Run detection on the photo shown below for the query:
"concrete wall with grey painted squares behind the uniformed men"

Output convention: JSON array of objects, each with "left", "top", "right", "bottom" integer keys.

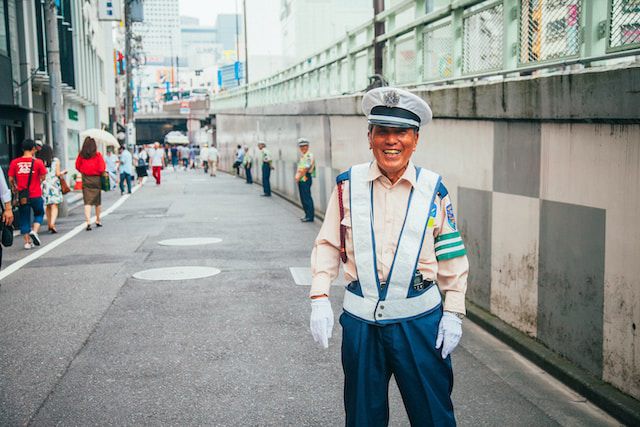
[{"left": 217, "top": 68, "right": 640, "bottom": 398}]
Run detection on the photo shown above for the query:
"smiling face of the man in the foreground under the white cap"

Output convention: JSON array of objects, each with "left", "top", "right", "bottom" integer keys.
[{"left": 368, "top": 125, "right": 418, "bottom": 182}]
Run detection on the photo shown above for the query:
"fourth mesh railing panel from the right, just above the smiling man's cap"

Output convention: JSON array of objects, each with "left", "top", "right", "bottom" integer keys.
[{"left": 424, "top": 22, "right": 454, "bottom": 81}]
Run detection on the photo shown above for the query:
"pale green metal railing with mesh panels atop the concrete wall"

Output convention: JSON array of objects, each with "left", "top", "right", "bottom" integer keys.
[{"left": 212, "top": 0, "right": 640, "bottom": 111}]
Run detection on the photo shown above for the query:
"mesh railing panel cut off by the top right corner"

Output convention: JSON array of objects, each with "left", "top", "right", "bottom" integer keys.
[{"left": 609, "top": 0, "right": 640, "bottom": 48}]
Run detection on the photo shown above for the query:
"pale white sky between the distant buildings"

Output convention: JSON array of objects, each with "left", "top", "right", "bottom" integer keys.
[{"left": 178, "top": 0, "right": 282, "bottom": 55}]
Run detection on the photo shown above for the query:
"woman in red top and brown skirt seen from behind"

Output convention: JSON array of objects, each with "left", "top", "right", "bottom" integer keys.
[{"left": 76, "top": 136, "right": 107, "bottom": 231}]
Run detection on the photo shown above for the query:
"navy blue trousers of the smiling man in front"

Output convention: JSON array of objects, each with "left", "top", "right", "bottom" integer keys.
[{"left": 340, "top": 306, "right": 456, "bottom": 427}]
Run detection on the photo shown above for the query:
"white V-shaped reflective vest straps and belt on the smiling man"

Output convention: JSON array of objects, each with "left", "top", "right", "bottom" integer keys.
[{"left": 344, "top": 163, "right": 441, "bottom": 322}]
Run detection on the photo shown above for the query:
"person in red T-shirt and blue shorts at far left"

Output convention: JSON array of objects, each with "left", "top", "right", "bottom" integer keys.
[{"left": 8, "top": 139, "right": 47, "bottom": 249}]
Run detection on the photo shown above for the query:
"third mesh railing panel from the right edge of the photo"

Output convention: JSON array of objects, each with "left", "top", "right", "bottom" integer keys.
[{"left": 462, "top": 1, "right": 504, "bottom": 74}]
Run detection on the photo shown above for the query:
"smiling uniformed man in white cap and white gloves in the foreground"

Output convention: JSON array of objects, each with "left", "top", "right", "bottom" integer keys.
[{"left": 310, "top": 87, "right": 469, "bottom": 426}]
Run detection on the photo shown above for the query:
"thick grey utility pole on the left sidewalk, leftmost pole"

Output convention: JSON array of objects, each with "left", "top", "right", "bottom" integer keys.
[{"left": 45, "top": 0, "right": 67, "bottom": 168}]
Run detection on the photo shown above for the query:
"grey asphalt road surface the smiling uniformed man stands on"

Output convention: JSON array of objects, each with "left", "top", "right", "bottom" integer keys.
[{"left": 0, "top": 171, "right": 616, "bottom": 426}]
